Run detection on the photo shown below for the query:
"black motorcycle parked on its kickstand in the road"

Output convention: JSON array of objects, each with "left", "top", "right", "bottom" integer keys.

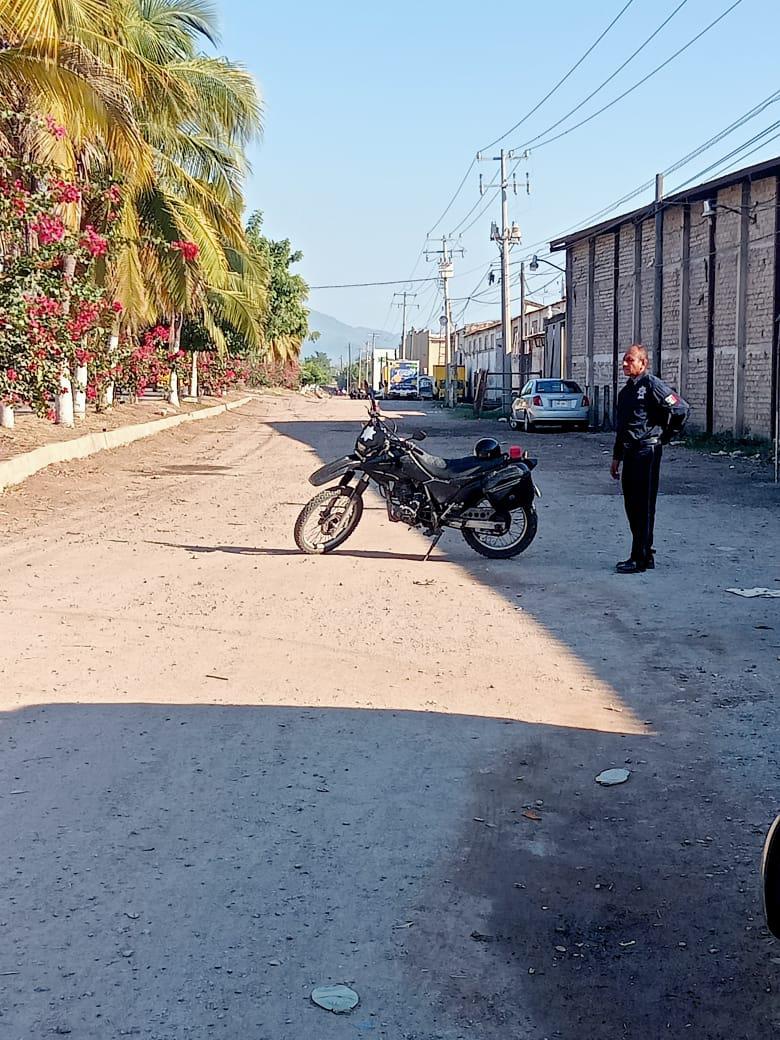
[{"left": 294, "top": 396, "right": 541, "bottom": 560}]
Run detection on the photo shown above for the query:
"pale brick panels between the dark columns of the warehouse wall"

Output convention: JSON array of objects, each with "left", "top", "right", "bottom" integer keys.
[{"left": 568, "top": 171, "right": 777, "bottom": 437}]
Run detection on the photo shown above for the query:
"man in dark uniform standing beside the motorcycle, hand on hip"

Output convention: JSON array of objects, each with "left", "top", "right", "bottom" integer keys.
[{"left": 609, "top": 343, "right": 690, "bottom": 574}]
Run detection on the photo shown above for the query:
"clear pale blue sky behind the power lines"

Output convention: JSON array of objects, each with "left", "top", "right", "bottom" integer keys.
[{"left": 218, "top": 0, "right": 780, "bottom": 331}]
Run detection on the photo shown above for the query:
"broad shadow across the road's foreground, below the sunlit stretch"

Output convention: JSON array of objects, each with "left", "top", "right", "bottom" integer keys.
[{"left": 0, "top": 704, "right": 780, "bottom": 1040}]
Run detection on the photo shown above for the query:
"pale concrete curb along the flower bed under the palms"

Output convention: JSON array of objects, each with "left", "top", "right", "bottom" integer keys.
[{"left": 0, "top": 397, "right": 253, "bottom": 492}]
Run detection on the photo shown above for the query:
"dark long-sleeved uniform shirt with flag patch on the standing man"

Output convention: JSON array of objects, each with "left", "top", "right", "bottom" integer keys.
[{"left": 613, "top": 372, "right": 688, "bottom": 460}]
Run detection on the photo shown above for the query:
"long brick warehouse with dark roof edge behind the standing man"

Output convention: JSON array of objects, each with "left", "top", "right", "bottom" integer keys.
[{"left": 550, "top": 158, "right": 780, "bottom": 438}]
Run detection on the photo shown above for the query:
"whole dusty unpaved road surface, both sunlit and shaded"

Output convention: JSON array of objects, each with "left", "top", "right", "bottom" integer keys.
[{"left": 0, "top": 397, "right": 780, "bottom": 1040}]
